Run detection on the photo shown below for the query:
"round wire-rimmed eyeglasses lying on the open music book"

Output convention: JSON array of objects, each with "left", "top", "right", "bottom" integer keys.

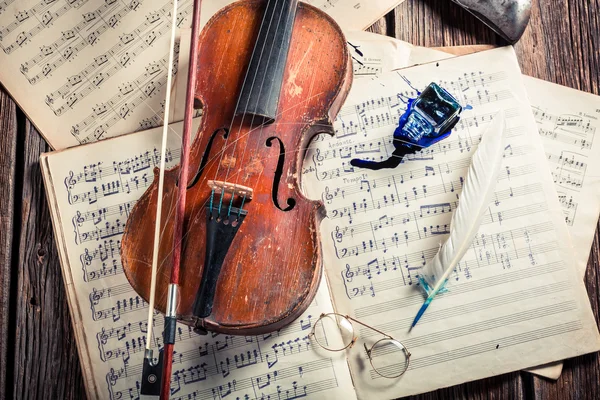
[{"left": 310, "top": 313, "right": 411, "bottom": 378}]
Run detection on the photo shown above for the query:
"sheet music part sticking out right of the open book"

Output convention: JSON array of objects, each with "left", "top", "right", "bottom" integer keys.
[{"left": 523, "top": 76, "right": 600, "bottom": 275}]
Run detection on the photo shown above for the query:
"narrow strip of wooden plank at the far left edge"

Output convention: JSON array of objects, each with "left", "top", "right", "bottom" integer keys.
[{"left": 0, "top": 88, "right": 17, "bottom": 399}]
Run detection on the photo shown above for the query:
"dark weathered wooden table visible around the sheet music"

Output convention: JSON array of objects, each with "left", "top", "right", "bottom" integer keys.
[{"left": 0, "top": 0, "right": 600, "bottom": 399}]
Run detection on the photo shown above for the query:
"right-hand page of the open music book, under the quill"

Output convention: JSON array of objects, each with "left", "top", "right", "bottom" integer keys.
[{"left": 304, "top": 48, "right": 600, "bottom": 399}]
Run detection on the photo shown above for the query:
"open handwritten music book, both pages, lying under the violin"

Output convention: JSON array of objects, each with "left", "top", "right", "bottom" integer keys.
[{"left": 41, "top": 48, "right": 600, "bottom": 399}]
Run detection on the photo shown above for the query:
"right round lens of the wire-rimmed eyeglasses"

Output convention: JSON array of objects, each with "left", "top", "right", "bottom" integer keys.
[{"left": 370, "top": 338, "right": 410, "bottom": 378}]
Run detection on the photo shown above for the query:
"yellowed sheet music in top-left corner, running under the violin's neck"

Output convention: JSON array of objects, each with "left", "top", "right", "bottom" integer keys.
[{"left": 0, "top": 0, "right": 406, "bottom": 149}]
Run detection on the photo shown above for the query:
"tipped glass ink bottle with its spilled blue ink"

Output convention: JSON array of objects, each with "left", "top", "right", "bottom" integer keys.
[{"left": 350, "top": 81, "right": 464, "bottom": 170}]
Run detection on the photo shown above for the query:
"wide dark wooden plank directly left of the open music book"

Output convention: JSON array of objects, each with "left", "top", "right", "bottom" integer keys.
[{"left": 13, "top": 121, "right": 85, "bottom": 399}]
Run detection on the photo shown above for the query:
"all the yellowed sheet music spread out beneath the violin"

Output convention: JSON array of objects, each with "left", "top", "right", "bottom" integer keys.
[{"left": 0, "top": 0, "right": 600, "bottom": 399}]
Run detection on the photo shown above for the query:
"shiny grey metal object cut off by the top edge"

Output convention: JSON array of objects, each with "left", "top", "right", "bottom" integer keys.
[{"left": 452, "top": 0, "right": 531, "bottom": 44}]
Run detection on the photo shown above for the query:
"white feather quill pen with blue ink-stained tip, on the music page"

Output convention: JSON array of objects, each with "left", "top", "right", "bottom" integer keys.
[{"left": 410, "top": 111, "right": 504, "bottom": 329}]
